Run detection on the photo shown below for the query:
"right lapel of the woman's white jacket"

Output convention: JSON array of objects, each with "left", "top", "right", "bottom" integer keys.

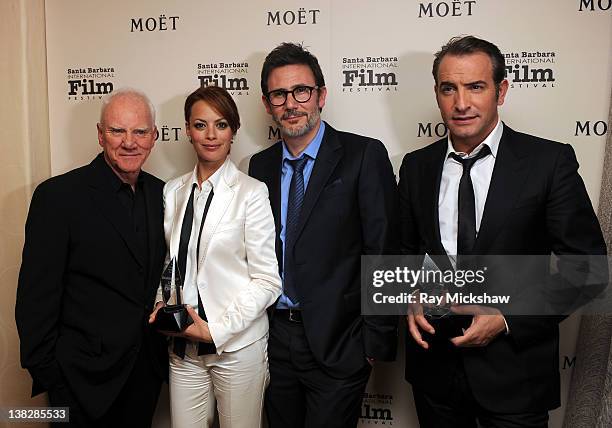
[{"left": 198, "top": 157, "right": 238, "bottom": 269}]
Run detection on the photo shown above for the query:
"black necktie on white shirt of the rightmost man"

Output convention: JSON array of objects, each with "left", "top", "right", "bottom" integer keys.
[{"left": 451, "top": 145, "right": 491, "bottom": 255}]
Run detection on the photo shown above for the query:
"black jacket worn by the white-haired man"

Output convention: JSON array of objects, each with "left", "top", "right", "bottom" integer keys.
[{"left": 15, "top": 154, "right": 167, "bottom": 417}]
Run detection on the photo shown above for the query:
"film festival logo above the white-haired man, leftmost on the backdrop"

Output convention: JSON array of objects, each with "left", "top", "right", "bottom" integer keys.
[{"left": 66, "top": 65, "right": 116, "bottom": 101}]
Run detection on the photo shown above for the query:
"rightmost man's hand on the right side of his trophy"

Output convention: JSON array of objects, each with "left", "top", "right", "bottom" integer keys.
[{"left": 450, "top": 305, "right": 506, "bottom": 347}]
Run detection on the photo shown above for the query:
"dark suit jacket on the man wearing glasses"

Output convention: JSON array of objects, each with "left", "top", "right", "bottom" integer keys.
[{"left": 249, "top": 124, "right": 398, "bottom": 377}]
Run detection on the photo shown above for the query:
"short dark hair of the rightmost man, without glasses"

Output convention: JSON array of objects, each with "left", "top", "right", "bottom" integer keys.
[{"left": 431, "top": 36, "right": 506, "bottom": 94}]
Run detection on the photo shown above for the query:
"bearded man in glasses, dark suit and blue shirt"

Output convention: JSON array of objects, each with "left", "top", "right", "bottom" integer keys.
[{"left": 249, "top": 43, "right": 398, "bottom": 428}]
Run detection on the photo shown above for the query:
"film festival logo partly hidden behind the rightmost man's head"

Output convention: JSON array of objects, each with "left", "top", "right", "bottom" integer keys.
[{"left": 504, "top": 51, "right": 557, "bottom": 89}]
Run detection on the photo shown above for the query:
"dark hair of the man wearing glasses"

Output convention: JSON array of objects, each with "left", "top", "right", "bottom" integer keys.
[{"left": 261, "top": 42, "right": 325, "bottom": 96}]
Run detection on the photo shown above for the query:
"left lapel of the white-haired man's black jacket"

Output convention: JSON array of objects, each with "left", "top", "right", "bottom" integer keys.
[{"left": 89, "top": 154, "right": 144, "bottom": 266}]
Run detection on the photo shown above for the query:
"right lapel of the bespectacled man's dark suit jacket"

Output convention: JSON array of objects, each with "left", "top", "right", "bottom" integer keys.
[{"left": 295, "top": 124, "right": 343, "bottom": 242}]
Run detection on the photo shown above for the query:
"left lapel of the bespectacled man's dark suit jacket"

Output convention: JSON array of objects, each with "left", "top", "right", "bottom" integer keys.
[{"left": 257, "top": 142, "right": 283, "bottom": 266}]
